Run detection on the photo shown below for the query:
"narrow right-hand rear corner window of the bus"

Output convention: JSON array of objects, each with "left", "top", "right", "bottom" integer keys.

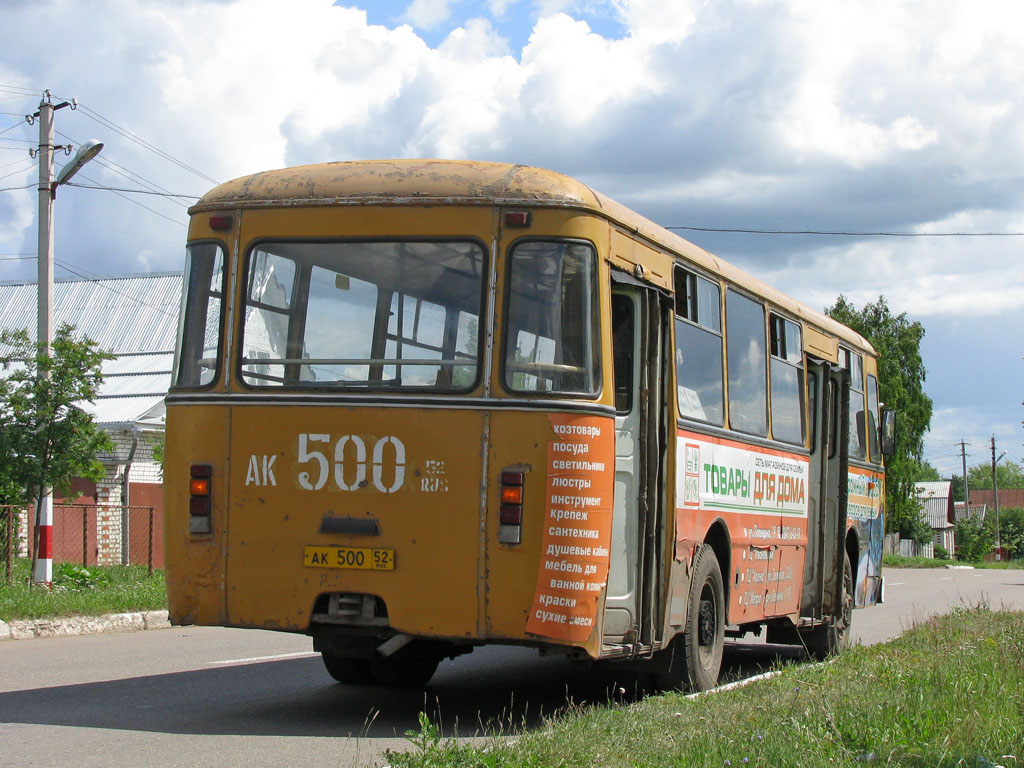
[{"left": 505, "top": 241, "right": 601, "bottom": 395}]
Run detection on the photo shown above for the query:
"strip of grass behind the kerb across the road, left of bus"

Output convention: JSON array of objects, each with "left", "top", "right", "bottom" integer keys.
[{"left": 0, "top": 560, "right": 167, "bottom": 622}]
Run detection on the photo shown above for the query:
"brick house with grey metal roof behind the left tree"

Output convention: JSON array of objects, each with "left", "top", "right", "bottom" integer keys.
[{"left": 0, "top": 272, "right": 181, "bottom": 562}]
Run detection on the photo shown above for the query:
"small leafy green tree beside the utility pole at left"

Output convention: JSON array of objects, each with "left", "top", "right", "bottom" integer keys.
[{"left": 0, "top": 325, "right": 114, "bottom": 573}]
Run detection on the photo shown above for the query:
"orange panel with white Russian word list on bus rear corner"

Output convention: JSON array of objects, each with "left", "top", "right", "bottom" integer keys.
[{"left": 526, "top": 414, "right": 615, "bottom": 642}]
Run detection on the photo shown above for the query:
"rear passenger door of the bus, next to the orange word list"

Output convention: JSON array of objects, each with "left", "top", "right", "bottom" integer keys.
[{"left": 604, "top": 284, "right": 666, "bottom": 647}]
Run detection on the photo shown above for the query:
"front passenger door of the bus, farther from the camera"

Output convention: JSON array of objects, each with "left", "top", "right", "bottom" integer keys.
[{"left": 800, "top": 359, "right": 846, "bottom": 618}]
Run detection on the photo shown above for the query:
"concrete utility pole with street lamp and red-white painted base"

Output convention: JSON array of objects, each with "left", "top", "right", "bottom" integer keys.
[{"left": 26, "top": 91, "right": 103, "bottom": 585}]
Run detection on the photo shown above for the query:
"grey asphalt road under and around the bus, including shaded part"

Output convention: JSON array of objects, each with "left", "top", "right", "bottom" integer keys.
[{"left": 0, "top": 569, "right": 1024, "bottom": 768}]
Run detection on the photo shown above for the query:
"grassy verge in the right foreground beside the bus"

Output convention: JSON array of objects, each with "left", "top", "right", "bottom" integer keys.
[{"left": 387, "top": 606, "right": 1024, "bottom": 768}]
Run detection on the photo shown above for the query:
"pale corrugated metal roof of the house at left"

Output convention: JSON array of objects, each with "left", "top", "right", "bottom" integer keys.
[{"left": 0, "top": 273, "right": 181, "bottom": 428}]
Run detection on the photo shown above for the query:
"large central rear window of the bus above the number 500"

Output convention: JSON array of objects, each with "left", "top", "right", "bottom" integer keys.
[{"left": 242, "top": 242, "right": 483, "bottom": 391}]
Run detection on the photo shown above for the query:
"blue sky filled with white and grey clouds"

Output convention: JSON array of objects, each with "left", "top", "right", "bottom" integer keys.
[{"left": 0, "top": 0, "right": 1024, "bottom": 476}]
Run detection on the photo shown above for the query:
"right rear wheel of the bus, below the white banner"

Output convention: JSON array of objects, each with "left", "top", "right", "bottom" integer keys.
[{"left": 685, "top": 544, "right": 725, "bottom": 690}]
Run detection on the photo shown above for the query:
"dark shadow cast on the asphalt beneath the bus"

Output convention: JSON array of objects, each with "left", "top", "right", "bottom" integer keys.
[{"left": 0, "top": 644, "right": 800, "bottom": 738}]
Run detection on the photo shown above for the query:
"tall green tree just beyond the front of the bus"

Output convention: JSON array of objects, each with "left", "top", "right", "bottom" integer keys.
[{"left": 825, "top": 295, "right": 932, "bottom": 540}]
